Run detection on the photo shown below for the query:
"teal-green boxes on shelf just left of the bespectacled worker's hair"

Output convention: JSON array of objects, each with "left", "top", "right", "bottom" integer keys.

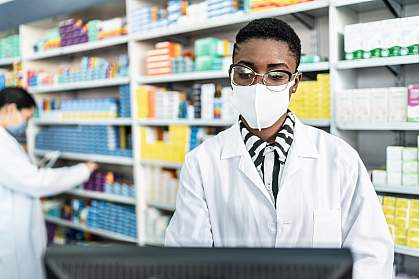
[{"left": 195, "top": 37, "right": 233, "bottom": 71}]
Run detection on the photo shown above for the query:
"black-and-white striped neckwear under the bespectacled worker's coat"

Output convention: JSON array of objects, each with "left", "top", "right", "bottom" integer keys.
[{"left": 239, "top": 111, "right": 295, "bottom": 203}]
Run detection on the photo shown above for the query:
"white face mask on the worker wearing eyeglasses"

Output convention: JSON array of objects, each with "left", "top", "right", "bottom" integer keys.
[{"left": 231, "top": 80, "right": 295, "bottom": 131}]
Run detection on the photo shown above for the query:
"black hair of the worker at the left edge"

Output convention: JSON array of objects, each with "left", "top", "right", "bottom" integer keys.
[{"left": 0, "top": 87, "right": 36, "bottom": 110}]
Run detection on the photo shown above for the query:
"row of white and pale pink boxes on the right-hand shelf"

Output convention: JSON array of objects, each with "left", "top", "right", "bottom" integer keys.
[{"left": 336, "top": 87, "right": 412, "bottom": 123}]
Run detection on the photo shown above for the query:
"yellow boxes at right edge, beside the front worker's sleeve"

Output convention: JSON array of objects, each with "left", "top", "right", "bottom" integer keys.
[{"left": 382, "top": 196, "right": 419, "bottom": 248}]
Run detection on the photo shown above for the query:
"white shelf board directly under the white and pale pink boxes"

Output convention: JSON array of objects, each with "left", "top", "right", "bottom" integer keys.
[{"left": 336, "top": 121, "right": 419, "bottom": 131}]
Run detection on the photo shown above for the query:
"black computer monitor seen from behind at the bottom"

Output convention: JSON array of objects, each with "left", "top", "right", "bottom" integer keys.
[{"left": 45, "top": 245, "right": 353, "bottom": 279}]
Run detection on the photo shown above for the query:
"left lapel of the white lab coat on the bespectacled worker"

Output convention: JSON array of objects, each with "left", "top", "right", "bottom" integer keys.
[{"left": 221, "top": 123, "right": 274, "bottom": 206}]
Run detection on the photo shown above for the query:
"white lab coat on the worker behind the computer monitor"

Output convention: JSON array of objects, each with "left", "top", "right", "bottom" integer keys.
[{"left": 166, "top": 119, "right": 394, "bottom": 279}]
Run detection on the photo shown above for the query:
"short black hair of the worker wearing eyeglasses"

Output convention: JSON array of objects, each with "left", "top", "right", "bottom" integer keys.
[{"left": 233, "top": 18, "right": 301, "bottom": 68}]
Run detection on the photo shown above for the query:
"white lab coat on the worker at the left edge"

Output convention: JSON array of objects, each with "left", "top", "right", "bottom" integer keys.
[{"left": 0, "top": 127, "right": 90, "bottom": 279}]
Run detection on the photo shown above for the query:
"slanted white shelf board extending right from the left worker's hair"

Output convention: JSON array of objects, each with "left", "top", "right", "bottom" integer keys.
[{"left": 29, "top": 77, "right": 129, "bottom": 94}]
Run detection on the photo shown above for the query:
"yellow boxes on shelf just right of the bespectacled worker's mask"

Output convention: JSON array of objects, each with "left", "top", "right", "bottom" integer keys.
[{"left": 289, "top": 74, "right": 331, "bottom": 120}]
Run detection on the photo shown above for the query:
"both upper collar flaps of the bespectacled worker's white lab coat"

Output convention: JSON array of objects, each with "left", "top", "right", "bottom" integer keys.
[{"left": 221, "top": 117, "right": 319, "bottom": 159}]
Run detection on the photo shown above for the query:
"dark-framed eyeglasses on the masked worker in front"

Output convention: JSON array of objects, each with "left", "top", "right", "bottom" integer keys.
[{"left": 229, "top": 64, "right": 298, "bottom": 92}]
